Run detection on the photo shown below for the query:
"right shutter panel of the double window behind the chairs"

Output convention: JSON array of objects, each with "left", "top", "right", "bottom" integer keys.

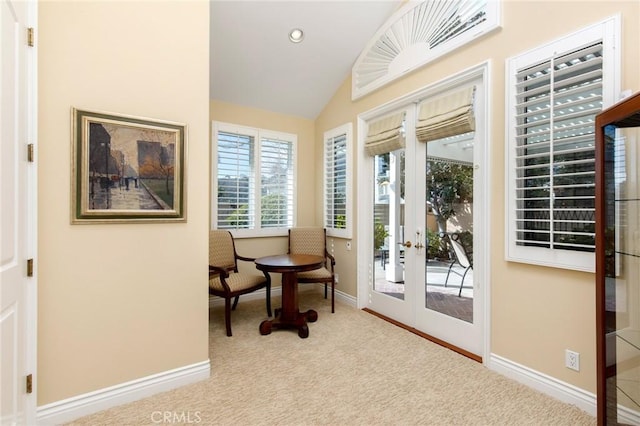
[{"left": 260, "top": 138, "right": 293, "bottom": 228}]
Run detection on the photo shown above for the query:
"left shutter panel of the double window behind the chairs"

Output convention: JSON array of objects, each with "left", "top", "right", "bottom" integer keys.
[{"left": 217, "top": 131, "right": 255, "bottom": 229}]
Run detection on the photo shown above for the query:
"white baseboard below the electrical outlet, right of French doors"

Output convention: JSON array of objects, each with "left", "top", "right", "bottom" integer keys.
[{"left": 485, "top": 354, "right": 596, "bottom": 417}]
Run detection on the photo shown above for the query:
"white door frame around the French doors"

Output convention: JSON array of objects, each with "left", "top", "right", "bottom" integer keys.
[{"left": 355, "top": 61, "right": 492, "bottom": 362}]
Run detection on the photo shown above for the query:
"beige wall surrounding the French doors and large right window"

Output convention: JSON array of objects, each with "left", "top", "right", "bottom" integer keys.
[{"left": 315, "top": 1, "right": 640, "bottom": 392}]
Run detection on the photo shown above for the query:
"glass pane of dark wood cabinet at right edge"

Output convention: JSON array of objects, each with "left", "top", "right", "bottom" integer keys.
[{"left": 604, "top": 126, "right": 640, "bottom": 424}]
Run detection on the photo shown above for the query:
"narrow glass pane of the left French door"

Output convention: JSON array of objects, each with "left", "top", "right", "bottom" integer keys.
[{"left": 373, "top": 149, "right": 405, "bottom": 300}]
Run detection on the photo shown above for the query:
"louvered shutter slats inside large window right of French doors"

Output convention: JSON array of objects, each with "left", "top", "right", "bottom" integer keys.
[{"left": 515, "top": 43, "right": 602, "bottom": 252}]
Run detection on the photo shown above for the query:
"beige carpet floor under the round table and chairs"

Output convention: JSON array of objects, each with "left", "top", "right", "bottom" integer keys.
[{"left": 70, "top": 291, "right": 596, "bottom": 426}]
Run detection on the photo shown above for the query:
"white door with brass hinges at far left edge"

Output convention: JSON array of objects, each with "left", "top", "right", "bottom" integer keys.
[{"left": 0, "top": 0, "right": 36, "bottom": 425}]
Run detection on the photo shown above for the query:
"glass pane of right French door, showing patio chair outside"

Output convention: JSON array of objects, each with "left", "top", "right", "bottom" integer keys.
[{"left": 424, "top": 132, "right": 474, "bottom": 323}]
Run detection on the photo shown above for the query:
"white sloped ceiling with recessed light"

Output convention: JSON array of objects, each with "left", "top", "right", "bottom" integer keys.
[{"left": 210, "top": 0, "right": 402, "bottom": 119}]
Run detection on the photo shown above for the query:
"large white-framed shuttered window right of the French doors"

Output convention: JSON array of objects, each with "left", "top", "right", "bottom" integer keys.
[{"left": 507, "top": 19, "right": 617, "bottom": 271}]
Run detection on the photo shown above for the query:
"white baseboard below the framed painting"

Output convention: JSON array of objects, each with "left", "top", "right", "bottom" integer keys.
[{"left": 37, "top": 360, "right": 211, "bottom": 425}]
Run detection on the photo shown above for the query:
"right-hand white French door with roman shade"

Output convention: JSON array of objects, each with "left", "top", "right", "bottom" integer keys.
[{"left": 413, "top": 78, "right": 488, "bottom": 357}]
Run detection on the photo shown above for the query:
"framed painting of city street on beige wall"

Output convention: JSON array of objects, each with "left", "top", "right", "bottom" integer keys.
[{"left": 72, "top": 108, "right": 186, "bottom": 223}]
